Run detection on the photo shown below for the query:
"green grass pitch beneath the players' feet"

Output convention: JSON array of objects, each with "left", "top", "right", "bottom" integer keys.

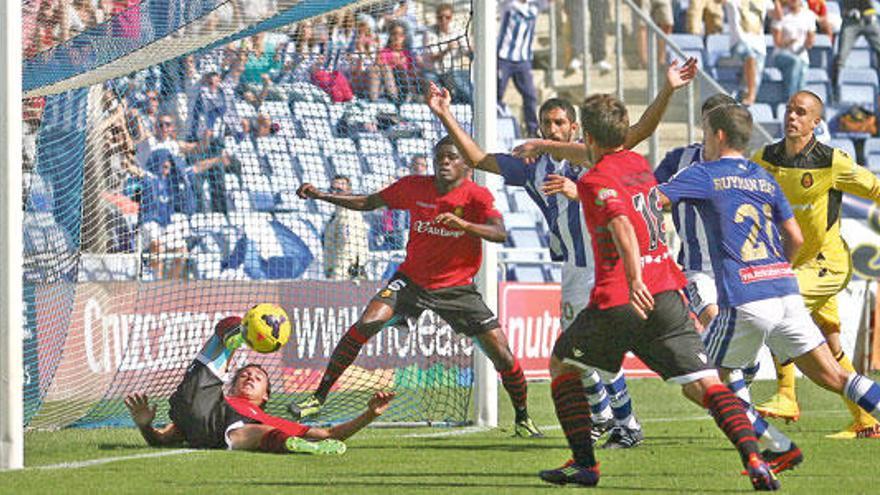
[{"left": 0, "top": 375, "right": 880, "bottom": 495}]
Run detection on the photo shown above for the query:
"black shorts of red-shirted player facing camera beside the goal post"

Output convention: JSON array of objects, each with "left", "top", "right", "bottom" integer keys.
[{"left": 373, "top": 272, "right": 500, "bottom": 337}]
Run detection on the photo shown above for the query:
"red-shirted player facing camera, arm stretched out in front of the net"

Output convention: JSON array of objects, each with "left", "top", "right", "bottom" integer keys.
[{"left": 290, "top": 136, "right": 541, "bottom": 436}]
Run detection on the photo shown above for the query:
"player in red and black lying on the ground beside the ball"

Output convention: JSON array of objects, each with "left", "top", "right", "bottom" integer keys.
[{"left": 125, "top": 316, "right": 394, "bottom": 454}]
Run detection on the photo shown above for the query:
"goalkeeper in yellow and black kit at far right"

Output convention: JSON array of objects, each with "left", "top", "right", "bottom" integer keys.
[{"left": 753, "top": 91, "right": 880, "bottom": 438}]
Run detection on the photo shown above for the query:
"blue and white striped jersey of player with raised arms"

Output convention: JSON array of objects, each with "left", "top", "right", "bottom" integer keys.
[{"left": 495, "top": 154, "right": 593, "bottom": 272}]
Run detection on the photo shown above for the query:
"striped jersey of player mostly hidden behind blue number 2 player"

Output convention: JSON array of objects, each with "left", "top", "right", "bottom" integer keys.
[{"left": 654, "top": 143, "right": 712, "bottom": 273}]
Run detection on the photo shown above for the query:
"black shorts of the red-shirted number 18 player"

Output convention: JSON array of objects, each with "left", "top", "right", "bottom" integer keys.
[{"left": 553, "top": 291, "right": 714, "bottom": 381}]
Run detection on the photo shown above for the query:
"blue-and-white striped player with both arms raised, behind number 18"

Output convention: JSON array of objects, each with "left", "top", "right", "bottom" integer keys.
[{"left": 426, "top": 59, "right": 696, "bottom": 448}]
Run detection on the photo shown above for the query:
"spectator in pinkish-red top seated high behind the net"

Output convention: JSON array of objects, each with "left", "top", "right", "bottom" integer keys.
[{"left": 377, "top": 22, "right": 419, "bottom": 102}]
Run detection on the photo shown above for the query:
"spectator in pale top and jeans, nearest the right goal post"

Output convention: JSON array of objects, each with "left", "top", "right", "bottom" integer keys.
[{"left": 424, "top": 3, "right": 473, "bottom": 104}]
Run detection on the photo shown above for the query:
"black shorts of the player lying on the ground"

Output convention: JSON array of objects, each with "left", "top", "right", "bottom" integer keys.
[{"left": 168, "top": 361, "right": 257, "bottom": 449}]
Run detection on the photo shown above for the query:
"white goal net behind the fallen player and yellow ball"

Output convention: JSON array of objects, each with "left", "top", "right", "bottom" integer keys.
[{"left": 22, "top": 0, "right": 474, "bottom": 428}]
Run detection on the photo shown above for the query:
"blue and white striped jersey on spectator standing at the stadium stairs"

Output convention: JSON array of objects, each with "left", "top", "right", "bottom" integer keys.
[{"left": 498, "top": 0, "right": 541, "bottom": 62}]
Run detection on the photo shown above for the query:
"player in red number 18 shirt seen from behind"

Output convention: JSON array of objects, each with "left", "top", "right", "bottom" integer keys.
[{"left": 540, "top": 95, "right": 779, "bottom": 490}]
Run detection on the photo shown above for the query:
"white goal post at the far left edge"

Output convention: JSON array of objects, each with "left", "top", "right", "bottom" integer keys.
[{"left": 0, "top": 0, "right": 24, "bottom": 470}]
